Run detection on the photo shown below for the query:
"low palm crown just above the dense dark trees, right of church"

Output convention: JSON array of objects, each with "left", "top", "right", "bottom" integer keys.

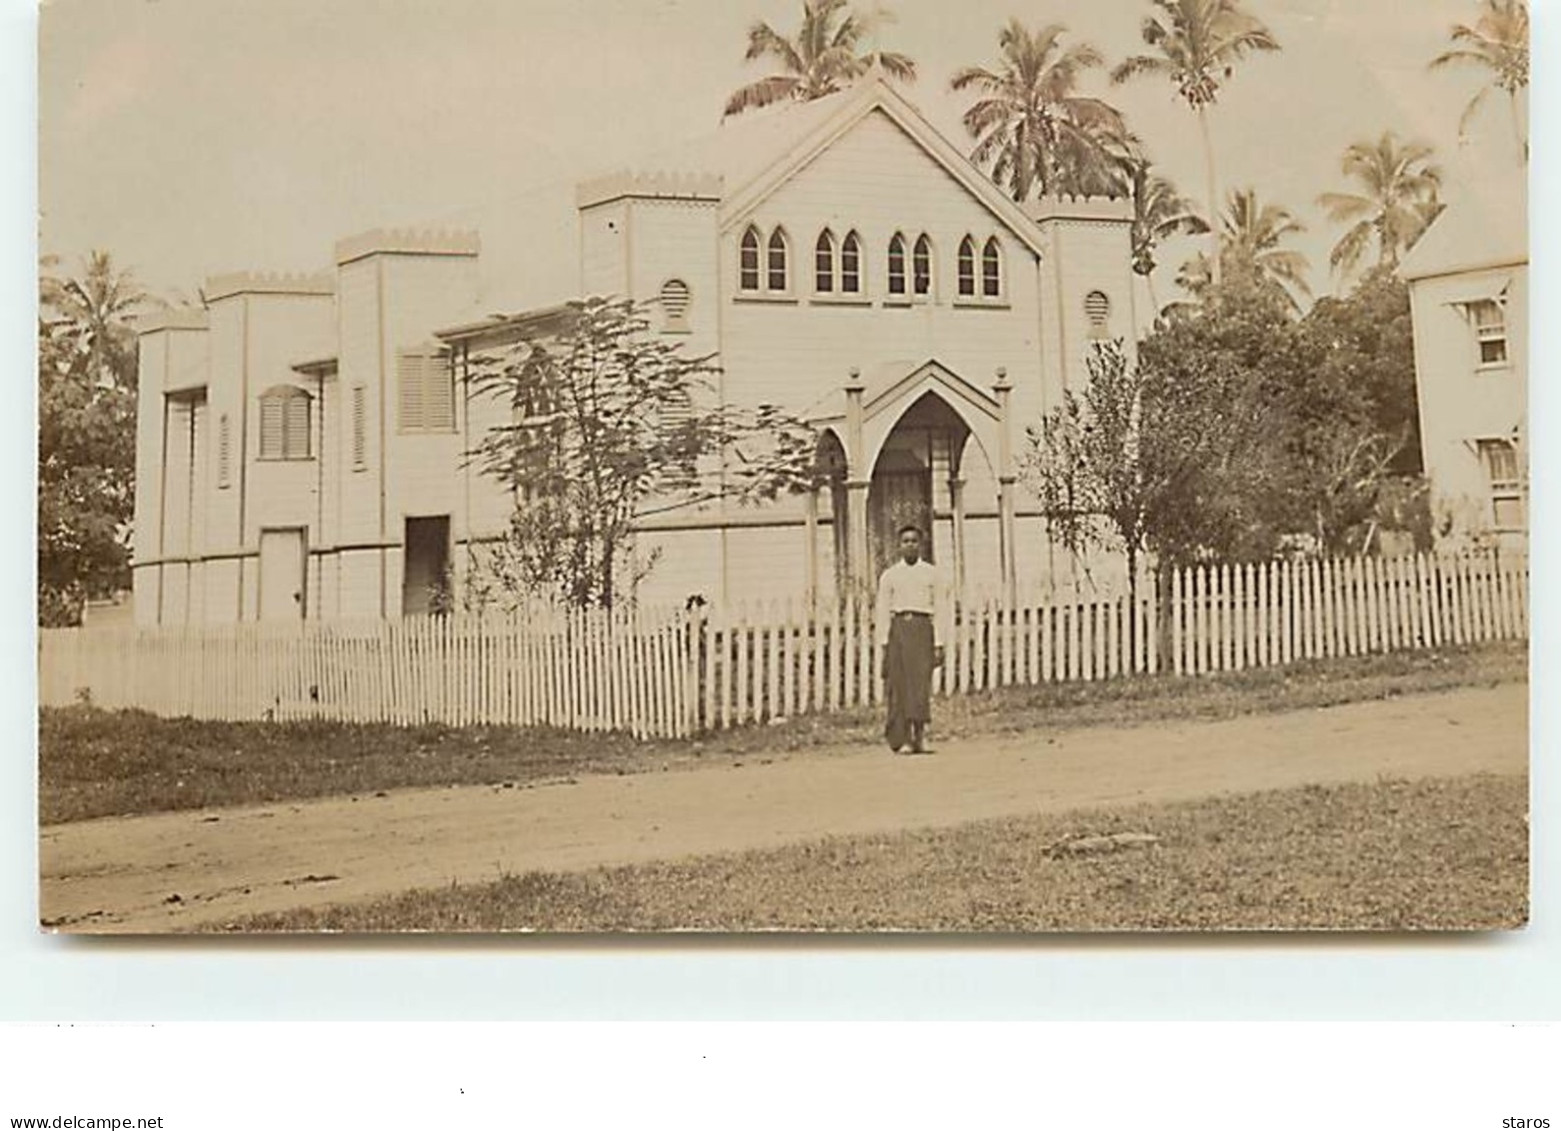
[{"left": 1177, "top": 187, "right": 1311, "bottom": 314}]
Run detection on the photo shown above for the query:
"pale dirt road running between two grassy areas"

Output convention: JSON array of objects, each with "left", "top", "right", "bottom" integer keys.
[{"left": 39, "top": 685, "right": 1528, "bottom": 933}]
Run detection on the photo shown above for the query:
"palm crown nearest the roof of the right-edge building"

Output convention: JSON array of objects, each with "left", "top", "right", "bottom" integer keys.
[{"left": 1317, "top": 129, "right": 1442, "bottom": 271}]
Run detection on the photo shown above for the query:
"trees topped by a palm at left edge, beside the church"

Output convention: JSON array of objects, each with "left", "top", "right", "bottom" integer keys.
[{"left": 37, "top": 251, "right": 147, "bottom": 626}]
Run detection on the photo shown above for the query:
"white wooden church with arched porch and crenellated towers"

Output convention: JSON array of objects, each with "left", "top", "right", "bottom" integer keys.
[{"left": 134, "top": 80, "right": 1136, "bottom": 624}]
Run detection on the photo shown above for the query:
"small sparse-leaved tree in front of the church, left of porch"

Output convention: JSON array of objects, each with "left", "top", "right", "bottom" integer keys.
[{"left": 468, "top": 298, "right": 813, "bottom": 608}]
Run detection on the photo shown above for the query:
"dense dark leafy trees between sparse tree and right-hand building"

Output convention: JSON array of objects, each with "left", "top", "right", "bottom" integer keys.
[{"left": 1141, "top": 271, "right": 1422, "bottom": 558}]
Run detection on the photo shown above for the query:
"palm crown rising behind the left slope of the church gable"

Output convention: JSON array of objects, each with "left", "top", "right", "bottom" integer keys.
[{"left": 723, "top": 0, "right": 916, "bottom": 117}]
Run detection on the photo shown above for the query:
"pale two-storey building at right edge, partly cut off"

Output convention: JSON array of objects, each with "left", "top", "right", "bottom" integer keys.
[{"left": 1400, "top": 170, "right": 1528, "bottom": 548}]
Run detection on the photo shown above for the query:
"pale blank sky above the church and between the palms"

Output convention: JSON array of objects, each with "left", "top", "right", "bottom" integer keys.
[{"left": 39, "top": 0, "right": 1536, "bottom": 301}]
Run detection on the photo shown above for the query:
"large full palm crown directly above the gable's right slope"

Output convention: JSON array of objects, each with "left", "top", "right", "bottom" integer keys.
[{"left": 951, "top": 19, "right": 1130, "bottom": 201}]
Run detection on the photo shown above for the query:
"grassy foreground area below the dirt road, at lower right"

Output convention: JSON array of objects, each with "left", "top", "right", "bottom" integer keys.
[{"left": 226, "top": 774, "right": 1528, "bottom": 931}]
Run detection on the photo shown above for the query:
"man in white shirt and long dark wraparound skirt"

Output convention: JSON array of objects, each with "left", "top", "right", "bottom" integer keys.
[{"left": 874, "top": 526, "right": 943, "bottom": 753}]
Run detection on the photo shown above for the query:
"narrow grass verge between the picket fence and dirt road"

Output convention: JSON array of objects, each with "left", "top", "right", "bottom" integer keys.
[{"left": 39, "top": 644, "right": 1528, "bottom": 824}]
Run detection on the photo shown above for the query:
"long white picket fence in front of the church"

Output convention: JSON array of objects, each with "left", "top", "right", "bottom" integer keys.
[{"left": 39, "top": 554, "right": 1528, "bottom": 738}]
